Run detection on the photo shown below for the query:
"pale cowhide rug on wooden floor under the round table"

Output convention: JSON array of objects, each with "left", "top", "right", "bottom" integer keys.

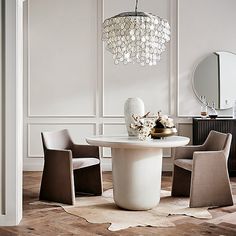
[{"left": 31, "top": 189, "right": 212, "bottom": 231}]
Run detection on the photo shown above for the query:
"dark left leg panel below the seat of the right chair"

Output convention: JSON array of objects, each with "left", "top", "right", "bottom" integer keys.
[{"left": 171, "top": 165, "right": 191, "bottom": 197}]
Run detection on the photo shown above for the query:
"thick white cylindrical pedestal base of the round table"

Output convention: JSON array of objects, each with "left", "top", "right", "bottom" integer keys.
[{"left": 111, "top": 148, "right": 162, "bottom": 210}]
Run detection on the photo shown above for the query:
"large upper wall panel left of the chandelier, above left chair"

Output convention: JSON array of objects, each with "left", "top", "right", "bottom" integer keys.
[{"left": 28, "top": 0, "right": 97, "bottom": 116}]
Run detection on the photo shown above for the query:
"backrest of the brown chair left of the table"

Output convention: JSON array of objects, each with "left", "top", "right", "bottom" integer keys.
[{"left": 41, "top": 129, "right": 73, "bottom": 152}]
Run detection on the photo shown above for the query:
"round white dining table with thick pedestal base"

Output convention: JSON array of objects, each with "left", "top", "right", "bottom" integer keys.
[{"left": 86, "top": 135, "right": 189, "bottom": 210}]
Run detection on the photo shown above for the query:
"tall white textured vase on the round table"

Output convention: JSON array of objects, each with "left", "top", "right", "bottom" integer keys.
[{"left": 124, "top": 98, "right": 145, "bottom": 136}]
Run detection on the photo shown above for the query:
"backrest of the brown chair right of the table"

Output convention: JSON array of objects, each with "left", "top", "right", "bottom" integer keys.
[{"left": 204, "top": 130, "right": 232, "bottom": 158}]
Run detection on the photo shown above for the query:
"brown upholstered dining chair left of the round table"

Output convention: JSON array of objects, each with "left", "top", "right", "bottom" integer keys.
[{"left": 39, "top": 129, "right": 102, "bottom": 205}]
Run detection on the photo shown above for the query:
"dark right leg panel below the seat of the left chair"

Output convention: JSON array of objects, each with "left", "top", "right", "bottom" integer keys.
[{"left": 74, "top": 164, "right": 103, "bottom": 195}]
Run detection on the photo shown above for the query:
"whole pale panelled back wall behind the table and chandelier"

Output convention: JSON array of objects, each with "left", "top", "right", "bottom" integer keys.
[{"left": 24, "top": 0, "right": 236, "bottom": 170}]
